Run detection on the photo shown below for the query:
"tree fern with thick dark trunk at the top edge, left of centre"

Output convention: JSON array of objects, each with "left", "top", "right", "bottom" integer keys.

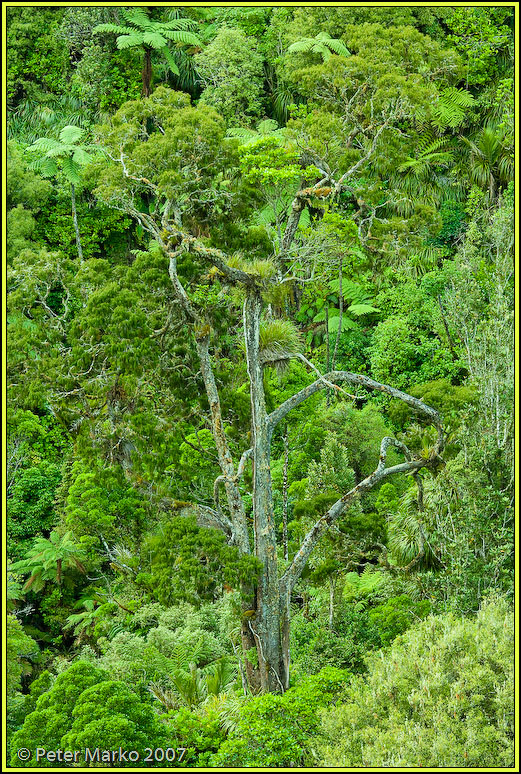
[{"left": 93, "top": 8, "right": 201, "bottom": 97}]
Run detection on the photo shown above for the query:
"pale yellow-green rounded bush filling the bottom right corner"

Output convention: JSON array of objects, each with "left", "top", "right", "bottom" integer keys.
[{"left": 320, "top": 600, "right": 514, "bottom": 768}]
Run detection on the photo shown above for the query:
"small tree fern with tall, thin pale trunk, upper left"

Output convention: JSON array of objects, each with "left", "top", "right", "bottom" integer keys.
[{"left": 28, "top": 126, "right": 96, "bottom": 261}]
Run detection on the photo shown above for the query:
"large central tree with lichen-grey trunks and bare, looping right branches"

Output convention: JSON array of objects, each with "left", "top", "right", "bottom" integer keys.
[{"left": 91, "top": 89, "right": 444, "bottom": 692}]
